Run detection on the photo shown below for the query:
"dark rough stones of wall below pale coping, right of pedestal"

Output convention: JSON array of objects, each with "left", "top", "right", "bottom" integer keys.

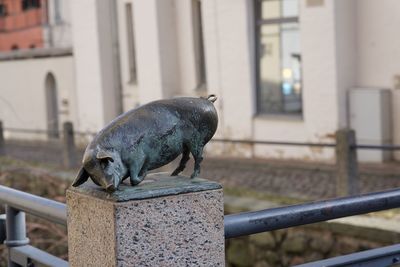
[{"left": 226, "top": 227, "right": 390, "bottom": 267}]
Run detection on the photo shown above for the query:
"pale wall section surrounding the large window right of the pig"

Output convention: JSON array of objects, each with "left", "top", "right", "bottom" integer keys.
[{"left": 203, "top": 0, "right": 339, "bottom": 160}]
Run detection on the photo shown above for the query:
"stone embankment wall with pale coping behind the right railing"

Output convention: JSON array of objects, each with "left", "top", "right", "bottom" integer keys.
[{"left": 224, "top": 191, "right": 400, "bottom": 267}]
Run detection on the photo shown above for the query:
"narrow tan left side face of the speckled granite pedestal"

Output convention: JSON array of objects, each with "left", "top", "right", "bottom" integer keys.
[{"left": 67, "top": 191, "right": 116, "bottom": 266}]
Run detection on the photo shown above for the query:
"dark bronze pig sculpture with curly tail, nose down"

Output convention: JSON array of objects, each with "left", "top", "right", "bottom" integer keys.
[{"left": 72, "top": 95, "right": 218, "bottom": 192}]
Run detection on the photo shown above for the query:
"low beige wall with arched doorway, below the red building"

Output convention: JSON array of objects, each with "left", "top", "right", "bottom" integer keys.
[{"left": 0, "top": 56, "right": 77, "bottom": 139}]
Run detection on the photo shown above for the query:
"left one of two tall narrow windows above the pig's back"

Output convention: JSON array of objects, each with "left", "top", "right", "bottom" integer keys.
[{"left": 125, "top": 3, "right": 137, "bottom": 83}]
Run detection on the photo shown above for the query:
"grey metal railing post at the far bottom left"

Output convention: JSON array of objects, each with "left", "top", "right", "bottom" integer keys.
[{"left": 4, "top": 206, "right": 29, "bottom": 267}]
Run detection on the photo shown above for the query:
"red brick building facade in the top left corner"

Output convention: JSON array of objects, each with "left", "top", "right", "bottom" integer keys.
[{"left": 0, "top": 0, "right": 47, "bottom": 51}]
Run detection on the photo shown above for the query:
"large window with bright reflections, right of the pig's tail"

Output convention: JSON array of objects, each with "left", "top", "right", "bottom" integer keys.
[{"left": 255, "top": 0, "right": 302, "bottom": 114}]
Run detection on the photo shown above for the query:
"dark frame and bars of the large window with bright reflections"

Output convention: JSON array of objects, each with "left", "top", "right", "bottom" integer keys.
[{"left": 253, "top": 0, "right": 304, "bottom": 118}]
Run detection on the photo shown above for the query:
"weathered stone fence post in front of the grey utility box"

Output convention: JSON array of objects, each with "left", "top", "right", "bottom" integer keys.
[{"left": 336, "top": 129, "right": 360, "bottom": 196}]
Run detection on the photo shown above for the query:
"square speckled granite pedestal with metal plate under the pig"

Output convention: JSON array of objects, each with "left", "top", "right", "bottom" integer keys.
[{"left": 67, "top": 174, "right": 225, "bottom": 266}]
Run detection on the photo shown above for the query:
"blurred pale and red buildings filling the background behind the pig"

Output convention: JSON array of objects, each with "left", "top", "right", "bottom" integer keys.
[{"left": 0, "top": 0, "right": 400, "bottom": 161}]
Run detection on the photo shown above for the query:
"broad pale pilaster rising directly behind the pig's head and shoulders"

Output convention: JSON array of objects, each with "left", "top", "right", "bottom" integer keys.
[{"left": 70, "top": 0, "right": 122, "bottom": 132}]
